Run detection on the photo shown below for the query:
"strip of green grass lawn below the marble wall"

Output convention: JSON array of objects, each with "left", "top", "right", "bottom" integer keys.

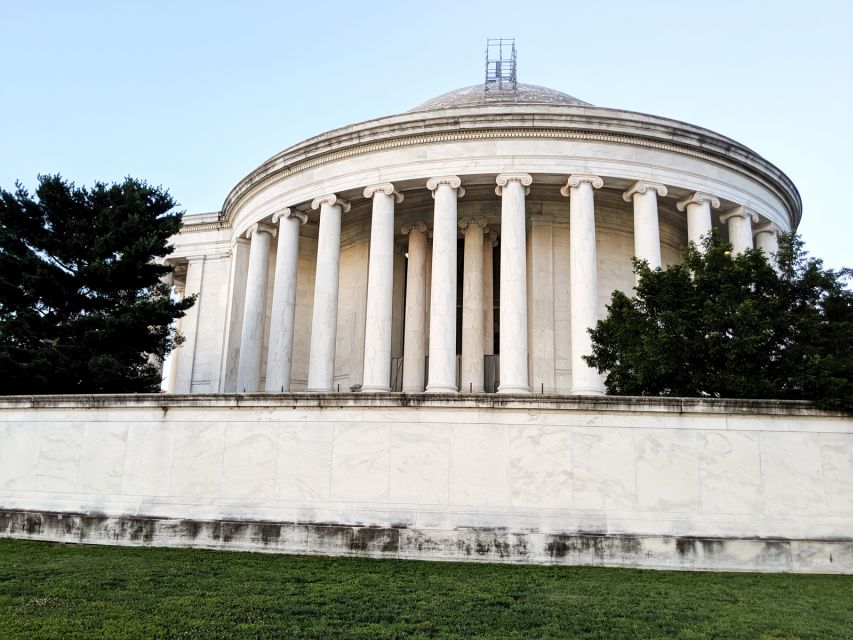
[{"left": 0, "top": 539, "right": 853, "bottom": 640}]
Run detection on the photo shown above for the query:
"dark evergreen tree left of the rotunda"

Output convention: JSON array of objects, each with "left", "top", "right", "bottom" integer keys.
[{"left": 0, "top": 176, "right": 194, "bottom": 394}]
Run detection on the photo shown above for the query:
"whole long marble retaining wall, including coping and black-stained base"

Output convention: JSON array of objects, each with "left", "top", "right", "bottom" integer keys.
[{"left": 0, "top": 394, "right": 853, "bottom": 573}]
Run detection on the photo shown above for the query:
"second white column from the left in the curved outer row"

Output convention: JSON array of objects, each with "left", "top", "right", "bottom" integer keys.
[{"left": 265, "top": 208, "right": 308, "bottom": 392}]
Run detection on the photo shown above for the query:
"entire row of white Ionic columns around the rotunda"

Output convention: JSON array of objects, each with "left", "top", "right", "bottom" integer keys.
[{"left": 231, "top": 173, "right": 778, "bottom": 394}]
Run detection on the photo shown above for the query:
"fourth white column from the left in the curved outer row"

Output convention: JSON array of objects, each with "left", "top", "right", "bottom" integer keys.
[{"left": 361, "top": 182, "right": 403, "bottom": 392}]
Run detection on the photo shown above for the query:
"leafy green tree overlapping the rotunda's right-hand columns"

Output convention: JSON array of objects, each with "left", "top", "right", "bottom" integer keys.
[{"left": 585, "top": 235, "right": 853, "bottom": 411}]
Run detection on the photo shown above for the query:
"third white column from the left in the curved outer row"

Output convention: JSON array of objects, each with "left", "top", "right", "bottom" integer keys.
[{"left": 306, "top": 193, "right": 350, "bottom": 392}]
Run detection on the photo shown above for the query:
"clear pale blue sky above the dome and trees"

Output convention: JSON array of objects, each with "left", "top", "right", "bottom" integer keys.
[{"left": 0, "top": 0, "right": 853, "bottom": 267}]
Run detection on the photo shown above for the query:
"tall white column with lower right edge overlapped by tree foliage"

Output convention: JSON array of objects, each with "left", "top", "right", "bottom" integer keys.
[{"left": 560, "top": 175, "right": 604, "bottom": 395}]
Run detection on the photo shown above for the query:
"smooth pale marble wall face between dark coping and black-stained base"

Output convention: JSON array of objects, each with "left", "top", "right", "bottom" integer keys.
[{"left": 0, "top": 394, "right": 853, "bottom": 570}]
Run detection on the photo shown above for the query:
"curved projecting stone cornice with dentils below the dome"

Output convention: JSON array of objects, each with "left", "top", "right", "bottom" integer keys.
[{"left": 221, "top": 105, "right": 802, "bottom": 226}]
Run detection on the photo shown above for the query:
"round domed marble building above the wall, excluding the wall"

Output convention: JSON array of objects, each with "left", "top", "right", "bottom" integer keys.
[{"left": 163, "top": 79, "right": 801, "bottom": 394}]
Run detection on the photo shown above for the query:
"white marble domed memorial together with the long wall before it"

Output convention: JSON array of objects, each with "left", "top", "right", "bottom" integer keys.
[{"left": 0, "top": 47, "right": 853, "bottom": 573}]
